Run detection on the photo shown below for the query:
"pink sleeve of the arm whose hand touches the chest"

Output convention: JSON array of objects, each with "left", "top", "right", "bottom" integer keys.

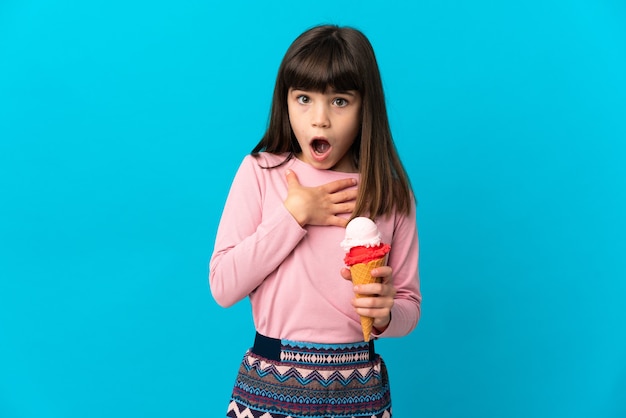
[{"left": 209, "top": 156, "right": 306, "bottom": 307}]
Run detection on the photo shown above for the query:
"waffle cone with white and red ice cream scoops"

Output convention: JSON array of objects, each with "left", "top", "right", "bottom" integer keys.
[{"left": 340, "top": 217, "right": 391, "bottom": 341}]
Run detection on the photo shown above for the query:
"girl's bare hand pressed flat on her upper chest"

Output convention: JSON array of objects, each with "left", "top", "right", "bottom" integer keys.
[{"left": 284, "top": 170, "right": 357, "bottom": 228}]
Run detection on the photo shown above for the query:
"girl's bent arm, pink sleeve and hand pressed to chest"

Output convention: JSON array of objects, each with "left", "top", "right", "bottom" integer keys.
[{"left": 209, "top": 157, "right": 356, "bottom": 306}]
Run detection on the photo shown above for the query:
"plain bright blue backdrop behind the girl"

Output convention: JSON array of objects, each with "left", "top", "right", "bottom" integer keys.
[{"left": 0, "top": 0, "right": 626, "bottom": 418}]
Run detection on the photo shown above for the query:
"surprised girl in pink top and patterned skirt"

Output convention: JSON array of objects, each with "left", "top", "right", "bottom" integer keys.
[{"left": 209, "top": 26, "right": 421, "bottom": 418}]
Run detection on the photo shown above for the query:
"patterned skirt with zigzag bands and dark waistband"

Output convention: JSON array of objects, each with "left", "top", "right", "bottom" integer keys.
[{"left": 226, "top": 334, "right": 391, "bottom": 418}]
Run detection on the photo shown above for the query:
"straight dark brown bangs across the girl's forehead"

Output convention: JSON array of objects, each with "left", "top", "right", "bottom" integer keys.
[{"left": 283, "top": 38, "right": 362, "bottom": 93}]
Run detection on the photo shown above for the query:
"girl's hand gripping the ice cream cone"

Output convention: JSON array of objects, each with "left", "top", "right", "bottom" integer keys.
[{"left": 341, "top": 266, "right": 396, "bottom": 332}]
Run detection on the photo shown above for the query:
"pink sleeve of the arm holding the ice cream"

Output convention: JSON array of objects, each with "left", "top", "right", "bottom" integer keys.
[{"left": 372, "top": 200, "right": 422, "bottom": 337}]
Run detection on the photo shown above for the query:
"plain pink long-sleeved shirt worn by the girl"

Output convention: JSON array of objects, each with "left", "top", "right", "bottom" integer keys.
[{"left": 209, "top": 153, "right": 421, "bottom": 344}]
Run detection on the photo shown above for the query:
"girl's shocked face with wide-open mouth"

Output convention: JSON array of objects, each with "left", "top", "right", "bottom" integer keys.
[{"left": 287, "top": 88, "right": 361, "bottom": 172}]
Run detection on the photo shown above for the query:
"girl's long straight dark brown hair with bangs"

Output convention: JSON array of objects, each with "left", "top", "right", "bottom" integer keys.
[{"left": 252, "top": 25, "right": 413, "bottom": 219}]
